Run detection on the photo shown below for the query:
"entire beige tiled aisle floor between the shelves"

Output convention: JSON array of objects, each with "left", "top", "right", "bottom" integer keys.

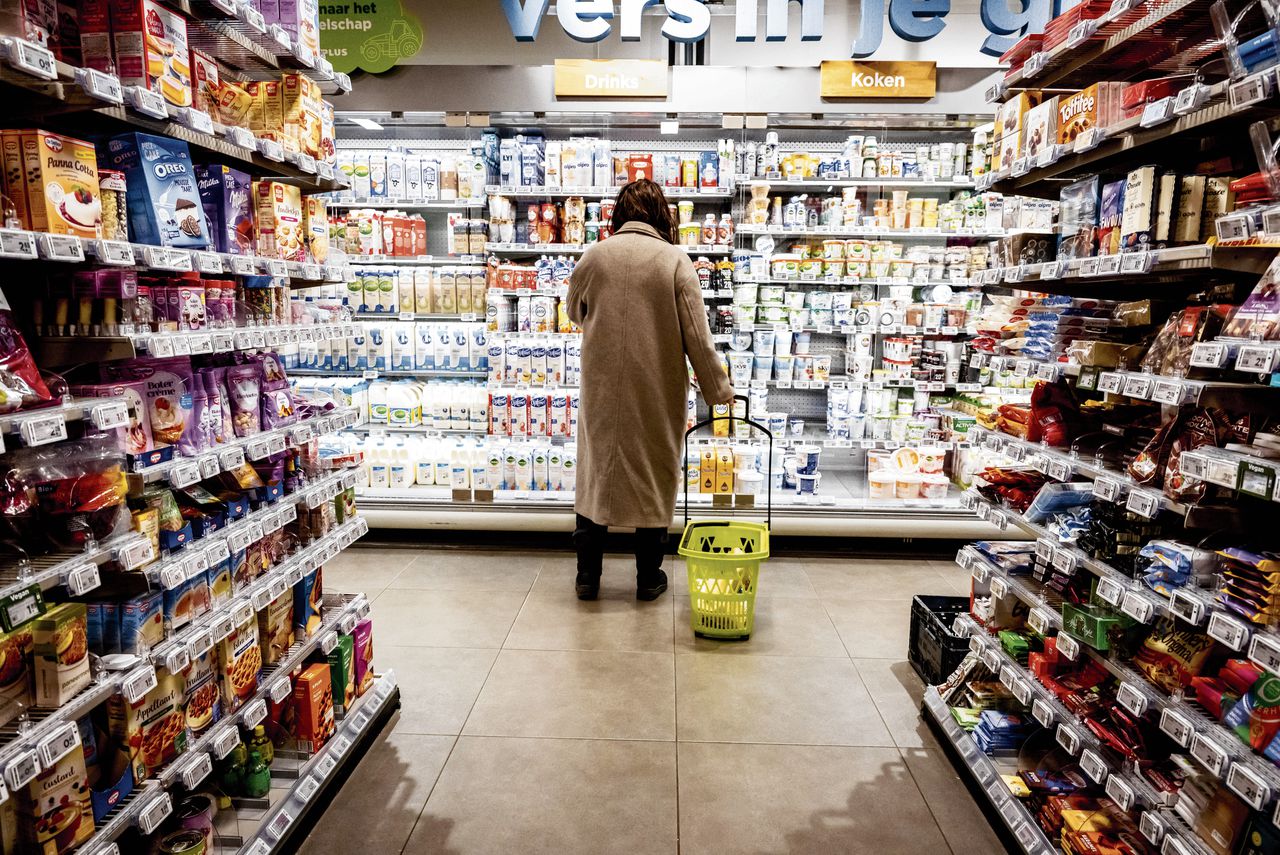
[{"left": 302, "top": 548, "right": 1005, "bottom": 855}]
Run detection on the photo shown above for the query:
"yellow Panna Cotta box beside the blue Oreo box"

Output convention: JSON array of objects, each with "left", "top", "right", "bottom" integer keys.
[{"left": 20, "top": 129, "right": 102, "bottom": 238}]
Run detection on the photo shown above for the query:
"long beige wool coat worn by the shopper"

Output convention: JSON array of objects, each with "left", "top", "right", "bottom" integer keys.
[{"left": 568, "top": 221, "right": 733, "bottom": 529}]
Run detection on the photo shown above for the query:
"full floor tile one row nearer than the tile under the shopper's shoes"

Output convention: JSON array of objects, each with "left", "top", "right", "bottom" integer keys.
[{"left": 462, "top": 650, "right": 676, "bottom": 740}]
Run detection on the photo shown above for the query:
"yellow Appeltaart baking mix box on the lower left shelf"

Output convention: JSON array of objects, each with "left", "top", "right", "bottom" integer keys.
[{"left": 106, "top": 668, "right": 191, "bottom": 781}]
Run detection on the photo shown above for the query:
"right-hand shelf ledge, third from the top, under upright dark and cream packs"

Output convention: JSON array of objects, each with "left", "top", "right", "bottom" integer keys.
[{"left": 975, "top": 243, "right": 1276, "bottom": 291}]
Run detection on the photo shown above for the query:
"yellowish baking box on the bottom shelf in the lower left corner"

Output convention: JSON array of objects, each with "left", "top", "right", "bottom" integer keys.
[{"left": 14, "top": 745, "right": 93, "bottom": 855}]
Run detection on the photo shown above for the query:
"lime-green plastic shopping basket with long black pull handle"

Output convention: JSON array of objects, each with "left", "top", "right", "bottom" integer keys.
[{"left": 677, "top": 396, "right": 773, "bottom": 639}]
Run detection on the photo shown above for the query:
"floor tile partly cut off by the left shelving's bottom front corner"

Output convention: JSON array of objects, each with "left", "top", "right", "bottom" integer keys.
[{"left": 375, "top": 647, "right": 498, "bottom": 735}]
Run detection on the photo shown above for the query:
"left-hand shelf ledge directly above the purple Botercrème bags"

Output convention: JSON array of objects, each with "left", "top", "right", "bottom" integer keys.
[{"left": 36, "top": 324, "right": 356, "bottom": 366}]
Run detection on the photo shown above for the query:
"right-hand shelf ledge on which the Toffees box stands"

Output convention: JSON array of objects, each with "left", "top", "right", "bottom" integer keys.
[{"left": 978, "top": 68, "right": 1276, "bottom": 197}]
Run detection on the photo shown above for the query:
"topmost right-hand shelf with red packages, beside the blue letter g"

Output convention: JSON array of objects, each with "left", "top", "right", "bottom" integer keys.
[{"left": 1000, "top": 0, "right": 1220, "bottom": 92}]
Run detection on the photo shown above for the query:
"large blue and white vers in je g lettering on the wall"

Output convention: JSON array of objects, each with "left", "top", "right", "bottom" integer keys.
[{"left": 502, "top": 0, "right": 1061, "bottom": 58}]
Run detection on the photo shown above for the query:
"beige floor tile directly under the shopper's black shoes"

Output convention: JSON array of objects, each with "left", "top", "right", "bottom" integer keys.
[{"left": 504, "top": 591, "right": 672, "bottom": 653}]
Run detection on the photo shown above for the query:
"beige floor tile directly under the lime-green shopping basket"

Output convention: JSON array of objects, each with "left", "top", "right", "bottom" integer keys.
[{"left": 676, "top": 590, "right": 847, "bottom": 657}]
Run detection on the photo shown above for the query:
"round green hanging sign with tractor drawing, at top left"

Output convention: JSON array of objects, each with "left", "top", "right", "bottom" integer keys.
[{"left": 320, "top": 0, "right": 422, "bottom": 73}]
